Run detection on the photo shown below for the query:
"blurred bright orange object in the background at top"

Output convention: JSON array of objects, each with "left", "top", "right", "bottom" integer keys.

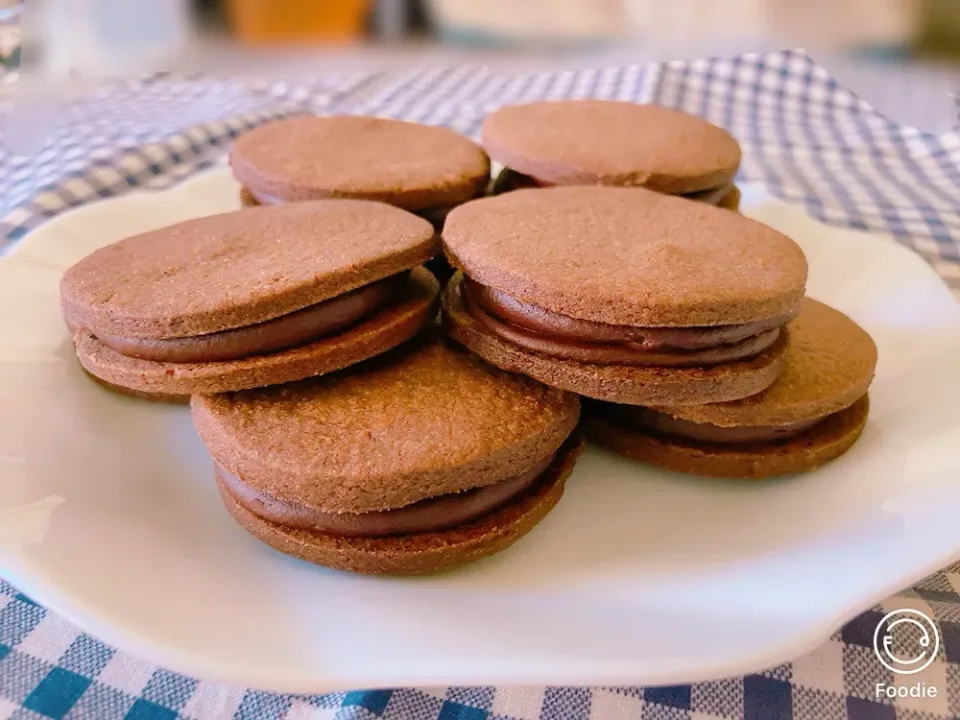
[{"left": 226, "top": 0, "right": 373, "bottom": 44}]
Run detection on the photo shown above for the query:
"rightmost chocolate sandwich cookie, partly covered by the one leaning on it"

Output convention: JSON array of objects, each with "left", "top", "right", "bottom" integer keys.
[{"left": 586, "top": 299, "right": 877, "bottom": 478}]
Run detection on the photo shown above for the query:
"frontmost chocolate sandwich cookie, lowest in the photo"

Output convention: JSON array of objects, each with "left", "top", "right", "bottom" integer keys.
[{"left": 192, "top": 333, "right": 580, "bottom": 575}]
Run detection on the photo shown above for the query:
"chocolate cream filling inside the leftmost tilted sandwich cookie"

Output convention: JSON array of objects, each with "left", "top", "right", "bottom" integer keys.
[{"left": 97, "top": 273, "right": 409, "bottom": 363}]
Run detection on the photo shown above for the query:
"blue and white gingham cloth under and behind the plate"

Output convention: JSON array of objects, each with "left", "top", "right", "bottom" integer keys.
[{"left": 0, "top": 52, "right": 960, "bottom": 720}]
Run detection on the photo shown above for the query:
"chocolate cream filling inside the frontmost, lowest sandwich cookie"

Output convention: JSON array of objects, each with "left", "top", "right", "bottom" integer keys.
[{"left": 216, "top": 456, "right": 553, "bottom": 537}]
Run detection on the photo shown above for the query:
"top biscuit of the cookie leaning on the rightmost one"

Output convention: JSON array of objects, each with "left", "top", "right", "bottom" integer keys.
[{"left": 443, "top": 186, "right": 807, "bottom": 327}]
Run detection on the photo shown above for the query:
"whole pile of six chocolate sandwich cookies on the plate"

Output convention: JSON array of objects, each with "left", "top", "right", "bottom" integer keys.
[{"left": 61, "top": 101, "right": 876, "bottom": 575}]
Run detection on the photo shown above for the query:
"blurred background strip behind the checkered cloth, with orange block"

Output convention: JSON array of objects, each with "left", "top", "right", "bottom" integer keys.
[{"left": 0, "top": 0, "right": 960, "bottom": 129}]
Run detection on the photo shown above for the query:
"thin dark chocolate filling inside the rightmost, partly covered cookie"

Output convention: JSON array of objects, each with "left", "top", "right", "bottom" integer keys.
[{"left": 601, "top": 403, "right": 825, "bottom": 445}]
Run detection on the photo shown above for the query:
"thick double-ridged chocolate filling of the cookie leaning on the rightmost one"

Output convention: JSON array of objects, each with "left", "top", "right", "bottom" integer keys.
[{"left": 460, "top": 277, "right": 796, "bottom": 367}]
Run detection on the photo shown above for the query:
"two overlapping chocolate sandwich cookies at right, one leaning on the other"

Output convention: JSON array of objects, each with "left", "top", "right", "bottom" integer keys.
[{"left": 443, "top": 187, "right": 877, "bottom": 478}]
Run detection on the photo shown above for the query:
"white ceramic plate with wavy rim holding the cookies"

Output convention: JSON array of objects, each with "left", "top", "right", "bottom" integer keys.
[{"left": 0, "top": 170, "right": 960, "bottom": 692}]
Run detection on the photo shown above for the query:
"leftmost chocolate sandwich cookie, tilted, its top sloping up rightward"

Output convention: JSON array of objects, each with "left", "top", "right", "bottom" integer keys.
[{"left": 60, "top": 200, "right": 439, "bottom": 400}]
